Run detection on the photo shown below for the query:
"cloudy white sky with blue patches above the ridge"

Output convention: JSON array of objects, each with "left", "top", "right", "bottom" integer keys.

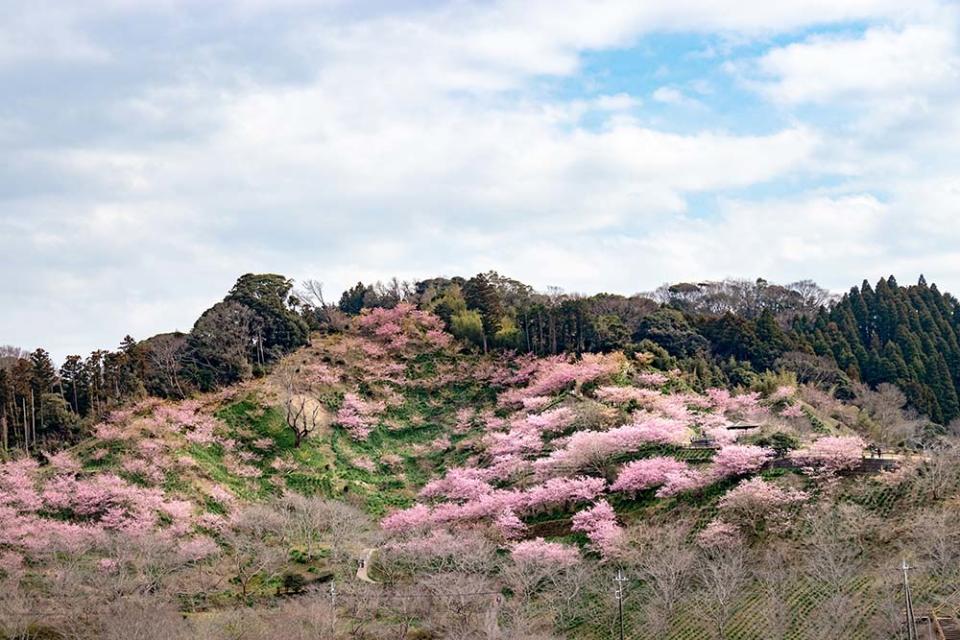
[{"left": 0, "top": 0, "right": 960, "bottom": 358}]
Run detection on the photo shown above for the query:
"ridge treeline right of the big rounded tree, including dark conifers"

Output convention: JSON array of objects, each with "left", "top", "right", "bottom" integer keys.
[{"left": 337, "top": 272, "right": 960, "bottom": 425}]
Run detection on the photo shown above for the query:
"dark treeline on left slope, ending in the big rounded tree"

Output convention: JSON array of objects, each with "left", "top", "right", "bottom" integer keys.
[{"left": 0, "top": 274, "right": 317, "bottom": 451}]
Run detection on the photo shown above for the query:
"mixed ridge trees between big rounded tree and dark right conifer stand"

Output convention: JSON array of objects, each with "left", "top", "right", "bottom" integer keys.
[{"left": 337, "top": 272, "right": 833, "bottom": 376}]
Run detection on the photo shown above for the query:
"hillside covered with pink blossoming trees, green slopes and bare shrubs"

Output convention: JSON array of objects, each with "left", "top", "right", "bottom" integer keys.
[{"left": 0, "top": 304, "right": 960, "bottom": 640}]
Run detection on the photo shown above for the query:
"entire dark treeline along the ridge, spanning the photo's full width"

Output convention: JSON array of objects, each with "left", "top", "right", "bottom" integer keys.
[{"left": 0, "top": 272, "right": 960, "bottom": 449}]
